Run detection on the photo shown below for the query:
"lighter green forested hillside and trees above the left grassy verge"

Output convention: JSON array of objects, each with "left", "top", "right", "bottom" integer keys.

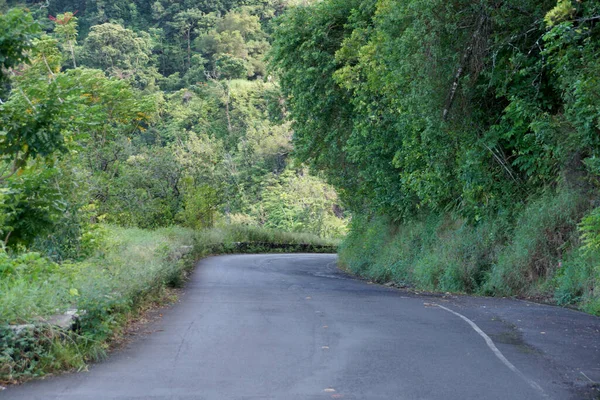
[{"left": 0, "top": 1, "right": 345, "bottom": 259}]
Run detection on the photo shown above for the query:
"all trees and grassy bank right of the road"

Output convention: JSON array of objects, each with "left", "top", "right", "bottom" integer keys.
[{"left": 271, "top": 0, "right": 600, "bottom": 312}]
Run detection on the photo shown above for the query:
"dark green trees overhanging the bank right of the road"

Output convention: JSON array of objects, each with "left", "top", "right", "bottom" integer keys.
[{"left": 272, "top": 0, "right": 598, "bottom": 220}]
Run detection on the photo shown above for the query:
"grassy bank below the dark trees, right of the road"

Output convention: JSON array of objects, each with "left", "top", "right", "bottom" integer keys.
[{"left": 340, "top": 189, "right": 600, "bottom": 315}]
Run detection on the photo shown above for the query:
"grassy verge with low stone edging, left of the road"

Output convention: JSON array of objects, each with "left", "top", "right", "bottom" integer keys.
[{"left": 0, "top": 226, "right": 337, "bottom": 384}]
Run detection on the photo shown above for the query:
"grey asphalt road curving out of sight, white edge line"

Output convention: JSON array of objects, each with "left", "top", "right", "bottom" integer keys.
[{"left": 0, "top": 255, "right": 600, "bottom": 400}]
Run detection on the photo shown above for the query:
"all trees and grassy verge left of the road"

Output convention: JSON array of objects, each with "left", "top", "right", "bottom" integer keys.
[{"left": 0, "top": 0, "right": 348, "bottom": 383}]
